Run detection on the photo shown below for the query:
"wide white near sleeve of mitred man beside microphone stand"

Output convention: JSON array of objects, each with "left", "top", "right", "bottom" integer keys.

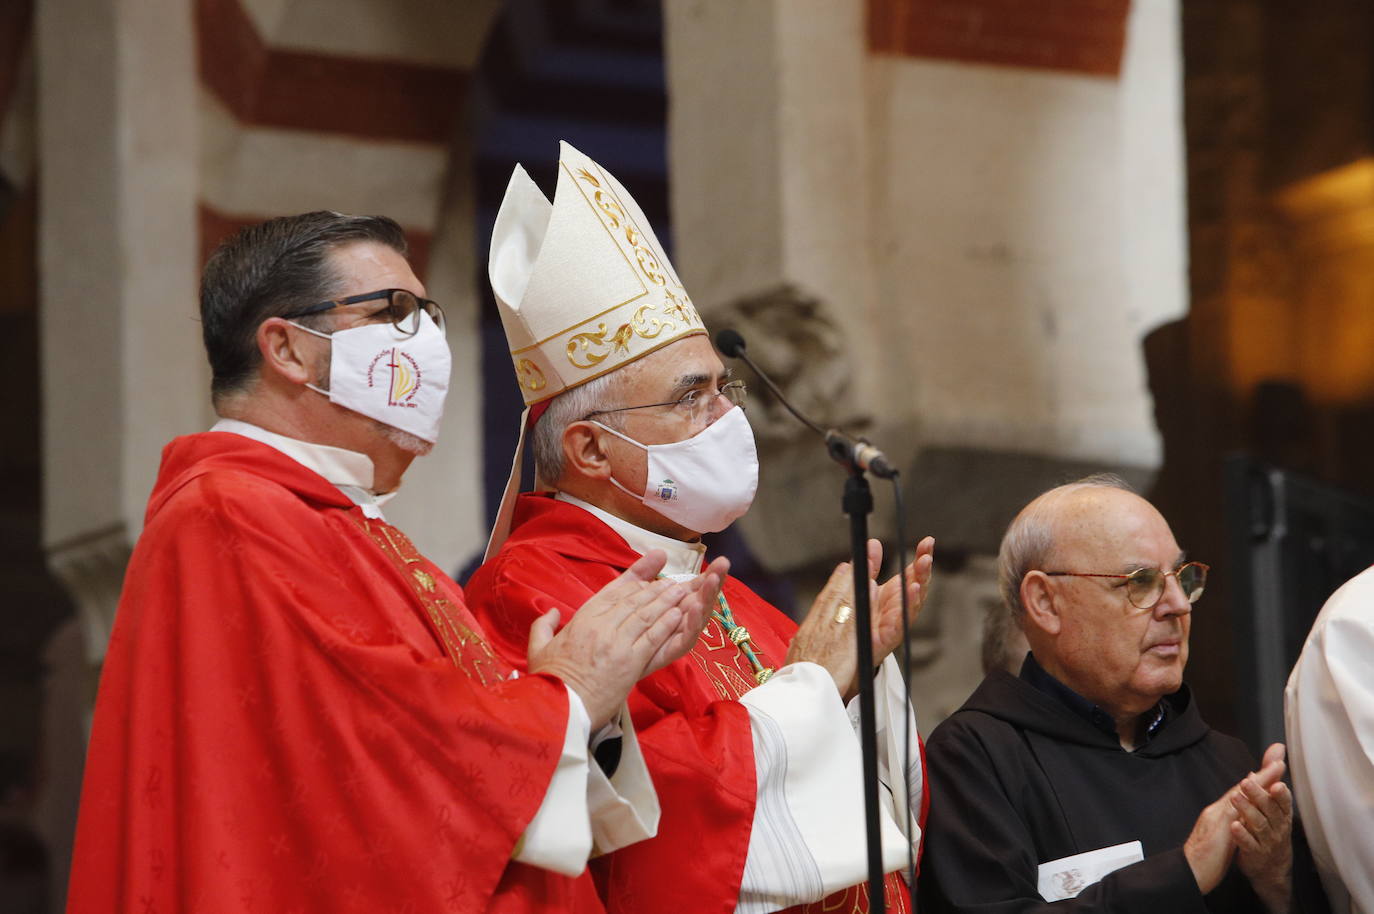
[{"left": 735, "top": 662, "right": 907, "bottom": 914}]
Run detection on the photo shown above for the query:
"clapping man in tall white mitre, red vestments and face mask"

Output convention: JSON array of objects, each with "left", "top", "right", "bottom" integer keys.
[{"left": 467, "top": 143, "right": 933, "bottom": 913}]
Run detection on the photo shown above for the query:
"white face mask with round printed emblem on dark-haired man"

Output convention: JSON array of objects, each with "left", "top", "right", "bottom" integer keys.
[{"left": 294, "top": 313, "right": 452, "bottom": 444}]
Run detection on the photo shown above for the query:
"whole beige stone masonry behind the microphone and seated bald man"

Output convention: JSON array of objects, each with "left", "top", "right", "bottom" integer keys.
[{"left": 665, "top": 0, "right": 1187, "bottom": 726}]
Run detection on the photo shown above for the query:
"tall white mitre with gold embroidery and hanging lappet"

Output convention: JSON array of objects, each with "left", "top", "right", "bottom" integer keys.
[{"left": 486, "top": 143, "right": 706, "bottom": 558}]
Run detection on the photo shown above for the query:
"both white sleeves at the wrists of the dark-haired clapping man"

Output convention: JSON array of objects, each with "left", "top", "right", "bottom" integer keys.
[{"left": 515, "top": 686, "right": 658, "bottom": 876}]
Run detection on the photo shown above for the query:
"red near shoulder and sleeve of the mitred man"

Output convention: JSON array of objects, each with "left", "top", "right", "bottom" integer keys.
[{"left": 467, "top": 544, "right": 754, "bottom": 911}]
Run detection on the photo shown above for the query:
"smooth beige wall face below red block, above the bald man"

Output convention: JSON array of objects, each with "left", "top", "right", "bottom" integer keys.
[{"left": 870, "top": 3, "right": 1186, "bottom": 467}]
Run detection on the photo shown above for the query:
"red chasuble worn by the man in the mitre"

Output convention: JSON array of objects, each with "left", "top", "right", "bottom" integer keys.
[{"left": 467, "top": 495, "right": 910, "bottom": 914}]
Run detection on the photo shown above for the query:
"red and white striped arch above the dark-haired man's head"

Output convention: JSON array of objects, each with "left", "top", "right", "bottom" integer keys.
[{"left": 191, "top": 0, "right": 500, "bottom": 276}]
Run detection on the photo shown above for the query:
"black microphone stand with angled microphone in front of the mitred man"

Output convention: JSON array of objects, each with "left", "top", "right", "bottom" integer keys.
[{"left": 717, "top": 331, "right": 890, "bottom": 914}]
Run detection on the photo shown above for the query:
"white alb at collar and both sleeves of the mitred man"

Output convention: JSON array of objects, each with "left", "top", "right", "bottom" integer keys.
[{"left": 556, "top": 492, "right": 923, "bottom": 914}]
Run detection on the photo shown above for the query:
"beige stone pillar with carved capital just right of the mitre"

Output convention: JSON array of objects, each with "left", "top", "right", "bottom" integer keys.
[{"left": 664, "top": 0, "right": 888, "bottom": 569}]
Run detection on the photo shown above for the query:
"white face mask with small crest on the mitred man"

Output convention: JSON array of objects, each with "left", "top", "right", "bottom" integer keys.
[{"left": 592, "top": 408, "right": 758, "bottom": 533}]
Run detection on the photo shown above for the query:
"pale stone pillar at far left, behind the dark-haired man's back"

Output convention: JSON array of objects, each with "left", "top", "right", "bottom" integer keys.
[{"left": 36, "top": 0, "right": 209, "bottom": 661}]
